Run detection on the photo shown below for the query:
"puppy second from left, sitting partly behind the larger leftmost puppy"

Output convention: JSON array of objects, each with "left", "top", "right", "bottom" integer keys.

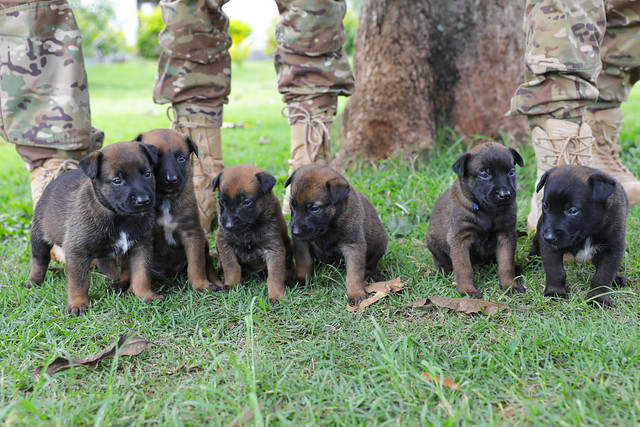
[{"left": 130, "top": 129, "right": 222, "bottom": 291}]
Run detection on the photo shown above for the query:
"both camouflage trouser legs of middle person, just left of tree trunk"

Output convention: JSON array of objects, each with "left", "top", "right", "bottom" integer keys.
[{"left": 153, "top": 0, "right": 354, "bottom": 125}]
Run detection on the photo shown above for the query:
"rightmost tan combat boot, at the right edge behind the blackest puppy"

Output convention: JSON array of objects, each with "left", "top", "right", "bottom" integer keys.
[{"left": 585, "top": 108, "right": 640, "bottom": 205}]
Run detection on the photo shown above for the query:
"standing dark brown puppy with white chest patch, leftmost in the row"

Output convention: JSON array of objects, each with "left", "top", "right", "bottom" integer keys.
[{"left": 26, "top": 142, "right": 163, "bottom": 315}]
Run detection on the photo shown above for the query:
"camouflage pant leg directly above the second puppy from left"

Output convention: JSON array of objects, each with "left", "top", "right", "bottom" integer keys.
[{"left": 153, "top": 0, "right": 231, "bottom": 126}]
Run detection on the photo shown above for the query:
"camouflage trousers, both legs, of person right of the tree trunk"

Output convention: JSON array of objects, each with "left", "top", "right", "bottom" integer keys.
[{"left": 508, "top": 0, "right": 640, "bottom": 126}]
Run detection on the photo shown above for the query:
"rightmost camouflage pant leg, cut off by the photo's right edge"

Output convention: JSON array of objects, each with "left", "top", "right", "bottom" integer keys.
[{"left": 589, "top": 0, "right": 640, "bottom": 110}]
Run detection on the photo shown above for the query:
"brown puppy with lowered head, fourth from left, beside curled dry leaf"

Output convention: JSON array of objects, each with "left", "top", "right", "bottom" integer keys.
[{"left": 284, "top": 165, "right": 389, "bottom": 305}]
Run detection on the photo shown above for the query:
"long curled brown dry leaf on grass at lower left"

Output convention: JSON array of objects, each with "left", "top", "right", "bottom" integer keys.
[{"left": 35, "top": 335, "right": 150, "bottom": 375}]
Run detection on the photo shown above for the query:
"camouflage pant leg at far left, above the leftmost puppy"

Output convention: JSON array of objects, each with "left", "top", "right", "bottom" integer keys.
[{"left": 0, "top": 0, "right": 104, "bottom": 167}]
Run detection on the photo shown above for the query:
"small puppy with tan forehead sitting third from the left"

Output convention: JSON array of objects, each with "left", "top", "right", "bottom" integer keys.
[{"left": 213, "top": 165, "right": 293, "bottom": 300}]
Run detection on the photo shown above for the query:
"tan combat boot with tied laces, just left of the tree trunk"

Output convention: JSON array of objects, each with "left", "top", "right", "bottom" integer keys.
[{"left": 282, "top": 104, "right": 334, "bottom": 214}]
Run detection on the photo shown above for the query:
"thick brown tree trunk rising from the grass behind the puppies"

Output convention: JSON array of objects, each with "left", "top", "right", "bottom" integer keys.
[{"left": 335, "top": 0, "right": 528, "bottom": 165}]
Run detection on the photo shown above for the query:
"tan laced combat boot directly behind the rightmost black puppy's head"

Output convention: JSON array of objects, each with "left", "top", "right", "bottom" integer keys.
[{"left": 527, "top": 119, "right": 593, "bottom": 230}]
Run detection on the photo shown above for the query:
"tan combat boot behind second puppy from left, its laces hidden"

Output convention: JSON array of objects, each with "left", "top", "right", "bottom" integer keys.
[{"left": 171, "top": 115, "right": 224, "bottom": 233}]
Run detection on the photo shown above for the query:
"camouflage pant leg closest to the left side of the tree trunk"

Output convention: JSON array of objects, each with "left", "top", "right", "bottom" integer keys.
[{"left": 274, "top": 0, "right": 354, "bottom": 124}]
